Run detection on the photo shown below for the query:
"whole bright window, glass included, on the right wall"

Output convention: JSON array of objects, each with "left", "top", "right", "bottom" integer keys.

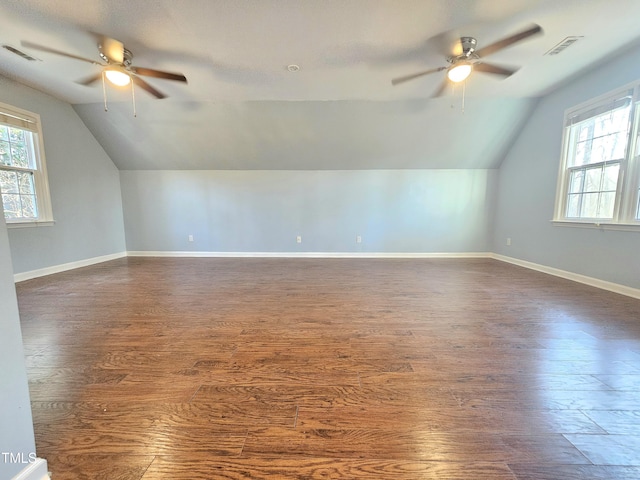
[{"left": 554, "top": 85, "right": 640, "bottom": 225}]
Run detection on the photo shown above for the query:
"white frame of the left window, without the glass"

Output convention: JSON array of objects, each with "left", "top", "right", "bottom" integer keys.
[{"left": 0, "top": 102, "right": 54, "bottom": 228}]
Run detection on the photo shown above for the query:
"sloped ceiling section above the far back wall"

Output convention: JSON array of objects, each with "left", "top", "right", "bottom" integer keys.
[{"left": 74, "top": 98, "right": 532, "bottom": 170}]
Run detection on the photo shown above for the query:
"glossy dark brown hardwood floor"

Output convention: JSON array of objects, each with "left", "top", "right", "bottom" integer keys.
[{"left": 12, "top": 258, "right": 640, "bottom": 480}]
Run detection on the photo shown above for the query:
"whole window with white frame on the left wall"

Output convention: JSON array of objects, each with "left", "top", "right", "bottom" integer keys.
[{"left": 0, "top": 103, "right": 53, "bottom": 225}]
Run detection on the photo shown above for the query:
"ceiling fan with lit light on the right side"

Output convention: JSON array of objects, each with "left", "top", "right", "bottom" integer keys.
[{"left": 391, "top": 25, "right": 542, "bottom": 97}]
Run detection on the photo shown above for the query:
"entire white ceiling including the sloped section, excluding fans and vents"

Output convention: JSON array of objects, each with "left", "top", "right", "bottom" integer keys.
[{"left": 0, "top": 0, "right": 640, "bottom": 169}]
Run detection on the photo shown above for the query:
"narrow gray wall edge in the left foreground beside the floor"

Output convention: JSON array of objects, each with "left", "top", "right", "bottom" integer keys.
[{"left": 0, "top": 216, "right": 36, "bottom": 478}]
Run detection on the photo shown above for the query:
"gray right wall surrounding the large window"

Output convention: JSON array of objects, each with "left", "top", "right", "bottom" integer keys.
[{"left": 493, "top": 49, "right": 640, "bottom": 288}]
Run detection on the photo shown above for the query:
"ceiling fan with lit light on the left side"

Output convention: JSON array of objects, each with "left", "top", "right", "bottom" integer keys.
[{"left": 22, "top": 36, "right": 187, "bottom": 98}]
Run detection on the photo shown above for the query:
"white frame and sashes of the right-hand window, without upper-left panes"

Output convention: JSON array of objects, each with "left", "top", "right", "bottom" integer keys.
[{"left": 552, "top": 82, "right": 640, "bottom": 230}]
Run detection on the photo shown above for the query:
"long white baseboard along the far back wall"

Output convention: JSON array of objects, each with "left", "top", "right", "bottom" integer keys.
[{"left": 127, "top": 251, "right": 491, "bottom": 258}]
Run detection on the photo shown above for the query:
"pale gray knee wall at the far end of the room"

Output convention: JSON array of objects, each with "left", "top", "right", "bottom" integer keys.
[{"left": 120, "top": 170, "right": 496, "bottom": 253}]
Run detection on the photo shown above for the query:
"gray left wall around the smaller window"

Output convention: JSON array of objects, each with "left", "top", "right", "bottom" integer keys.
[{"left": 0, "top": 76, "right": 125, "bottom": 273}]
